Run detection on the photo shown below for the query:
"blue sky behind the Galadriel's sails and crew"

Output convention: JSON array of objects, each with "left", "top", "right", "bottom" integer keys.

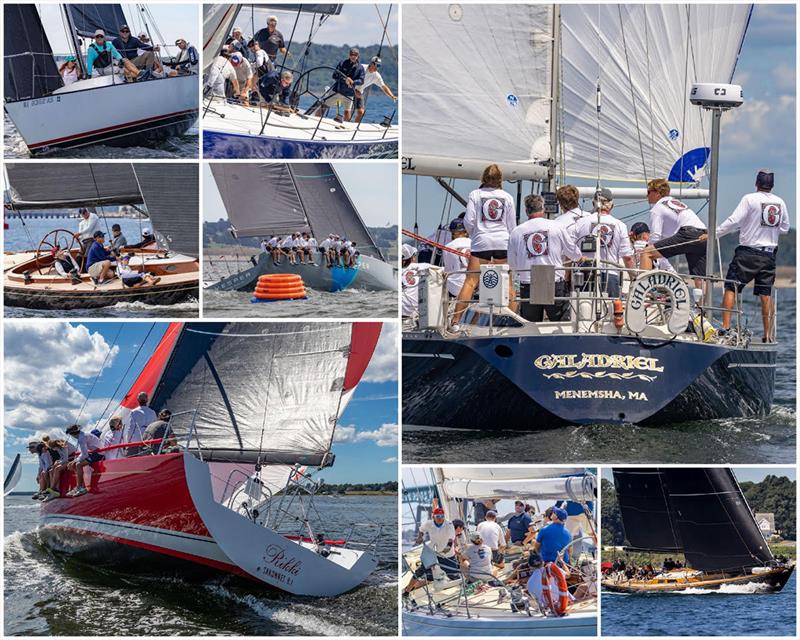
[{"left": 402, "top": 4, "right": 797, "bottom": 235}]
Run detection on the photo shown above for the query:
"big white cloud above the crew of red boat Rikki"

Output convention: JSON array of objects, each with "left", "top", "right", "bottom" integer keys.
[{"left": 3, "top": 322, "right": 119, "bottom": 432}]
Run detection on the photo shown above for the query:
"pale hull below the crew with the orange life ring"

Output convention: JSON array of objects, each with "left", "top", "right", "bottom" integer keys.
[{"left": 402, "top": 611, "right": 597, "bottom": 637}]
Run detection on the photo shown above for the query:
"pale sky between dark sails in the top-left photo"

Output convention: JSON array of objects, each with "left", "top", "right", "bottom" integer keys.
[{"left": 37, "top": 3, "right": 202, "bottom": 55}]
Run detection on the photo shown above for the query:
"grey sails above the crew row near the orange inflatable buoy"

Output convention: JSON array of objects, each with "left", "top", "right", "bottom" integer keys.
[{"left": 211, "top": 162, "right": 384, "bottom": 260}]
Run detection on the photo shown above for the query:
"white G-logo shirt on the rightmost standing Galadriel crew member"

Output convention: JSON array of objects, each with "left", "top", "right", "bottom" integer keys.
[{"left": 717, "top": 191, "right": 789, "bottom": 249}]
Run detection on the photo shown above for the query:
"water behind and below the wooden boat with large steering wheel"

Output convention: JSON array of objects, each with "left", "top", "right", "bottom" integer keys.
[{"left": 3, "top": 214, "right": 199, "bottom": 318}]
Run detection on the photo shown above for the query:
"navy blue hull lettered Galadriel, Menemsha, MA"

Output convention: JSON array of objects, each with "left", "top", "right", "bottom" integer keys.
[{"left": 403, "top": 332, "right": 776, "bottom": 430}]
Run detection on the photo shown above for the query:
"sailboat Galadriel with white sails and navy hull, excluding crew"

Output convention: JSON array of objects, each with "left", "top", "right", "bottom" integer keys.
[{"left": 402, "top": 4, "right": 778, "bottom": 430}]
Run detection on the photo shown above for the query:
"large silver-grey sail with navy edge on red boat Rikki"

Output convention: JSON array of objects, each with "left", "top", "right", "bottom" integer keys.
[{"left": 145, "top": 322, "right": 377, "bottom": 466}]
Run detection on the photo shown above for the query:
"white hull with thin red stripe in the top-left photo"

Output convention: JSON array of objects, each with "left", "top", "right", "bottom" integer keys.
[{"left": 5, "top": 75, "right": 198, "bottom": 155}]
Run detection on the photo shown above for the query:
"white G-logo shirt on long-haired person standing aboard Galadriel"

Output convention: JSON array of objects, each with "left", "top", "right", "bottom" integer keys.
[{"left": 464, "top": 189, "right": 517, "bottom": 253}]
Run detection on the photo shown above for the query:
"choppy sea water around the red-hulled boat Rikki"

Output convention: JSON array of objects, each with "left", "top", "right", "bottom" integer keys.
[{"left": 3, "top": 496, "right": 397, "bottom": 636}]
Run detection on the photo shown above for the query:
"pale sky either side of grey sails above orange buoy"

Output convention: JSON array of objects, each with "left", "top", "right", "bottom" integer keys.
[{"left": 203, "top": 162, "right": 398, "bottom": 227}]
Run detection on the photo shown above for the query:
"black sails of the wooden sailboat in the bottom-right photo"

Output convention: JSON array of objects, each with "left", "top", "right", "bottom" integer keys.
[{"left": 614, "top": 468, "right": 774, "bottom": 571}]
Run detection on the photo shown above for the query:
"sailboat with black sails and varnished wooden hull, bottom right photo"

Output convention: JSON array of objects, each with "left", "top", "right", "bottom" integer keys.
[{"left": 602, "top": 467, "right": 794, "bottom": 593}]
